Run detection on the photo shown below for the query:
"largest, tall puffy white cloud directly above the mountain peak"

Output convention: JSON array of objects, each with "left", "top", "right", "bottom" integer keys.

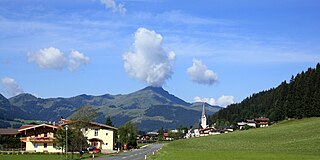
[{"left": 123, "top": 28, "right": 175, "bottom": 86}]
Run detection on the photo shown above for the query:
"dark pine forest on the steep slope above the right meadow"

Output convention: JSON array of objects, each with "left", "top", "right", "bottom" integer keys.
[{"left": 209, "top": 63, "right": 320, "bottom": 125}]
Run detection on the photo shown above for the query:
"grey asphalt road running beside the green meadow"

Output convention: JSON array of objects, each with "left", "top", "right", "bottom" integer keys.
[{"left": 94, "top": 144, "right": 164, "bottom": 160}]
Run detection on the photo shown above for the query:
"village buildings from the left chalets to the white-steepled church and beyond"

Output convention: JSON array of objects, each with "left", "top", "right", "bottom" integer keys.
[{"left": 0, "top": 104, "right": 269, "bottom": 154}]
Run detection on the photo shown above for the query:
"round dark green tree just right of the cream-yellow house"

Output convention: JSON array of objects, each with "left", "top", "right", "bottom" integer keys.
[{"left": 118, "top": 121, "right": 138, "bottom": 148}]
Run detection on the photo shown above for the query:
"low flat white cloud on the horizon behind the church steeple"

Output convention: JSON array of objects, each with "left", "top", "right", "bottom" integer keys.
[{"left": 194, "top": 95, "right": 234, "bottom": 107}]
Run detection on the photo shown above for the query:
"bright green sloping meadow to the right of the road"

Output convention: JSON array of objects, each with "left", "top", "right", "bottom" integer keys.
[{"left": 149, "top": 118, "right": 320, "bottom": 160}]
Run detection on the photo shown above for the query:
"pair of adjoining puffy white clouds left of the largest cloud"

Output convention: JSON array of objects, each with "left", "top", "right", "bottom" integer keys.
[{"left": 27, "top": 47, "right": 90, "bottom": 72}]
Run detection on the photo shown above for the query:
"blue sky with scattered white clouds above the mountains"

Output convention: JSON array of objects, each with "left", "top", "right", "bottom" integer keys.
[{"left": 0, "top": 0, "right": 320, "bottom": 106}]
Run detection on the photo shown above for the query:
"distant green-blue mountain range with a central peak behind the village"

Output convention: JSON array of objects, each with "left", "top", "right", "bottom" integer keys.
[{"left": 0, "top": 86, "right": 221, "bottom": 131}]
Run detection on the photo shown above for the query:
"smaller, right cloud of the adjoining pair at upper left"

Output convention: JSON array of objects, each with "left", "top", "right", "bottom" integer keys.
[{"left": 68, "top": 50, "right": 90, "bottom": 72}]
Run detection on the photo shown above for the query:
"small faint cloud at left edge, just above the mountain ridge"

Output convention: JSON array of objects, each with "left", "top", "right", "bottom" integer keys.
[{"left": 1, "top": 77, "right": 23, "bottom": 96}]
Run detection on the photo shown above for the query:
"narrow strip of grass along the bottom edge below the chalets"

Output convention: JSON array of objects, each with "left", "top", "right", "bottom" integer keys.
[{"left": 0, "top": 153, "right": 104, "bottom": 160}]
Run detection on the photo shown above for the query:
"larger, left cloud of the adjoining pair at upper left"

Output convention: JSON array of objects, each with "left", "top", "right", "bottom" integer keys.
[{"left": 27, "top": 47, "right": 67, "bottom": 70}]
